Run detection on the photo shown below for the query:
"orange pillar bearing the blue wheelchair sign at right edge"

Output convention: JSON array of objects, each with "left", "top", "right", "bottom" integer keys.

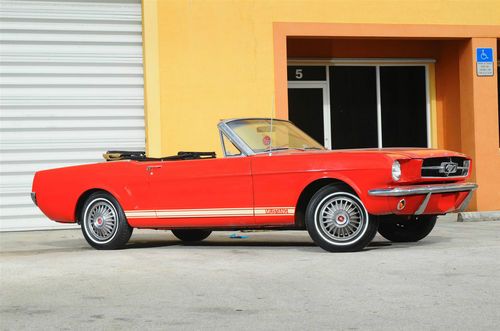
[{"left": 459, "top": 38, "right": 500, "bottom": 210}]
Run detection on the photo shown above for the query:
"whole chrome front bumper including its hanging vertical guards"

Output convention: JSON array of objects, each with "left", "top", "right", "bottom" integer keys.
[{"left": 368, "top": 183, "right": 477, "bottom": 215}]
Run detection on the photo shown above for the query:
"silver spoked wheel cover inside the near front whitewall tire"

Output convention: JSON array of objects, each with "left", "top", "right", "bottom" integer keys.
[{"left": 316, "top": 196, "right": 366, "bottom": 242}]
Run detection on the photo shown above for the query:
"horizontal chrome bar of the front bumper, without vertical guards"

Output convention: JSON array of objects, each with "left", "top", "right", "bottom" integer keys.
[{"left": 368, "top": 183, "right": 477, "bottom": 197}]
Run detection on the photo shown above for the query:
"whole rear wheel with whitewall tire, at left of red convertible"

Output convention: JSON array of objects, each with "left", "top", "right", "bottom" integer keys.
[{"left": 80, "top": 192, "right": 133, "bottom": 249}]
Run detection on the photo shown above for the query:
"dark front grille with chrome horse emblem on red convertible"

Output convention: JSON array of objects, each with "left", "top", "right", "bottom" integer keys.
[{"left": 421, "top": 157, "right": 470, "bottom": 178}]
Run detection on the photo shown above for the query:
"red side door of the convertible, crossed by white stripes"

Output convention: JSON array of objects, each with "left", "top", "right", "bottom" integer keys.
[{"left": 146, "top": 157, "right": 254, "bottom": 227}]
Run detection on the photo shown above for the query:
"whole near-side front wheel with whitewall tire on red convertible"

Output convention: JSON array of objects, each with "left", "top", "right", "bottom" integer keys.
[{"left": 306, "top": 185, "right": 378, "bottom": 252}]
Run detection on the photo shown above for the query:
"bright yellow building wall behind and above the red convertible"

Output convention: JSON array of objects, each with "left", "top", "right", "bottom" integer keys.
[{"left": 143, "top": 0, "right": 500, "bottom": 209}]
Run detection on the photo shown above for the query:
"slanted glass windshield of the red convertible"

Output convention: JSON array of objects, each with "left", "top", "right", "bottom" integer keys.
[{"left": 227, "top": 119, "right": 324, "bottom": 153}]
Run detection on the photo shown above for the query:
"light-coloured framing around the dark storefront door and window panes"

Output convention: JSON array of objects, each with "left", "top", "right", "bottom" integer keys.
[{"left": 287, "top": 58, "right": 436, "bottom": 149}]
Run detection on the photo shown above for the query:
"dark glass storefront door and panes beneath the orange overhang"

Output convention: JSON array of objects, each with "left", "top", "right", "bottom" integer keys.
[{"left": 288, "top": 60, "right": 431, "bottom": 149}]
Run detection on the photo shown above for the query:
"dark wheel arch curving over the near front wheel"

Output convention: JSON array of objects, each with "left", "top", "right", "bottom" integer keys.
[{"left": 295, "top": 177, "right": 359, "bottom": 229}]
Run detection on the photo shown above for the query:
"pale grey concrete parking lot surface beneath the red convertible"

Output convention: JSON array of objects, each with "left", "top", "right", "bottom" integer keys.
[{"left": 0, "top": 218, "right": 500, "bottom": 330}]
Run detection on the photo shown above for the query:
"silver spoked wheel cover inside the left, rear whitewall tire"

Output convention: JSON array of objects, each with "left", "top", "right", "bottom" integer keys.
[{"left": 84, "top": 198, "right": 118, "bottom": 242}]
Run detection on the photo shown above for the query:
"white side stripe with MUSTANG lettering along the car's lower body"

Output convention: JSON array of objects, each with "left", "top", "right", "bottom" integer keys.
[{"left": 125, "top": 207, "right": 295, "bottom": 218}]
